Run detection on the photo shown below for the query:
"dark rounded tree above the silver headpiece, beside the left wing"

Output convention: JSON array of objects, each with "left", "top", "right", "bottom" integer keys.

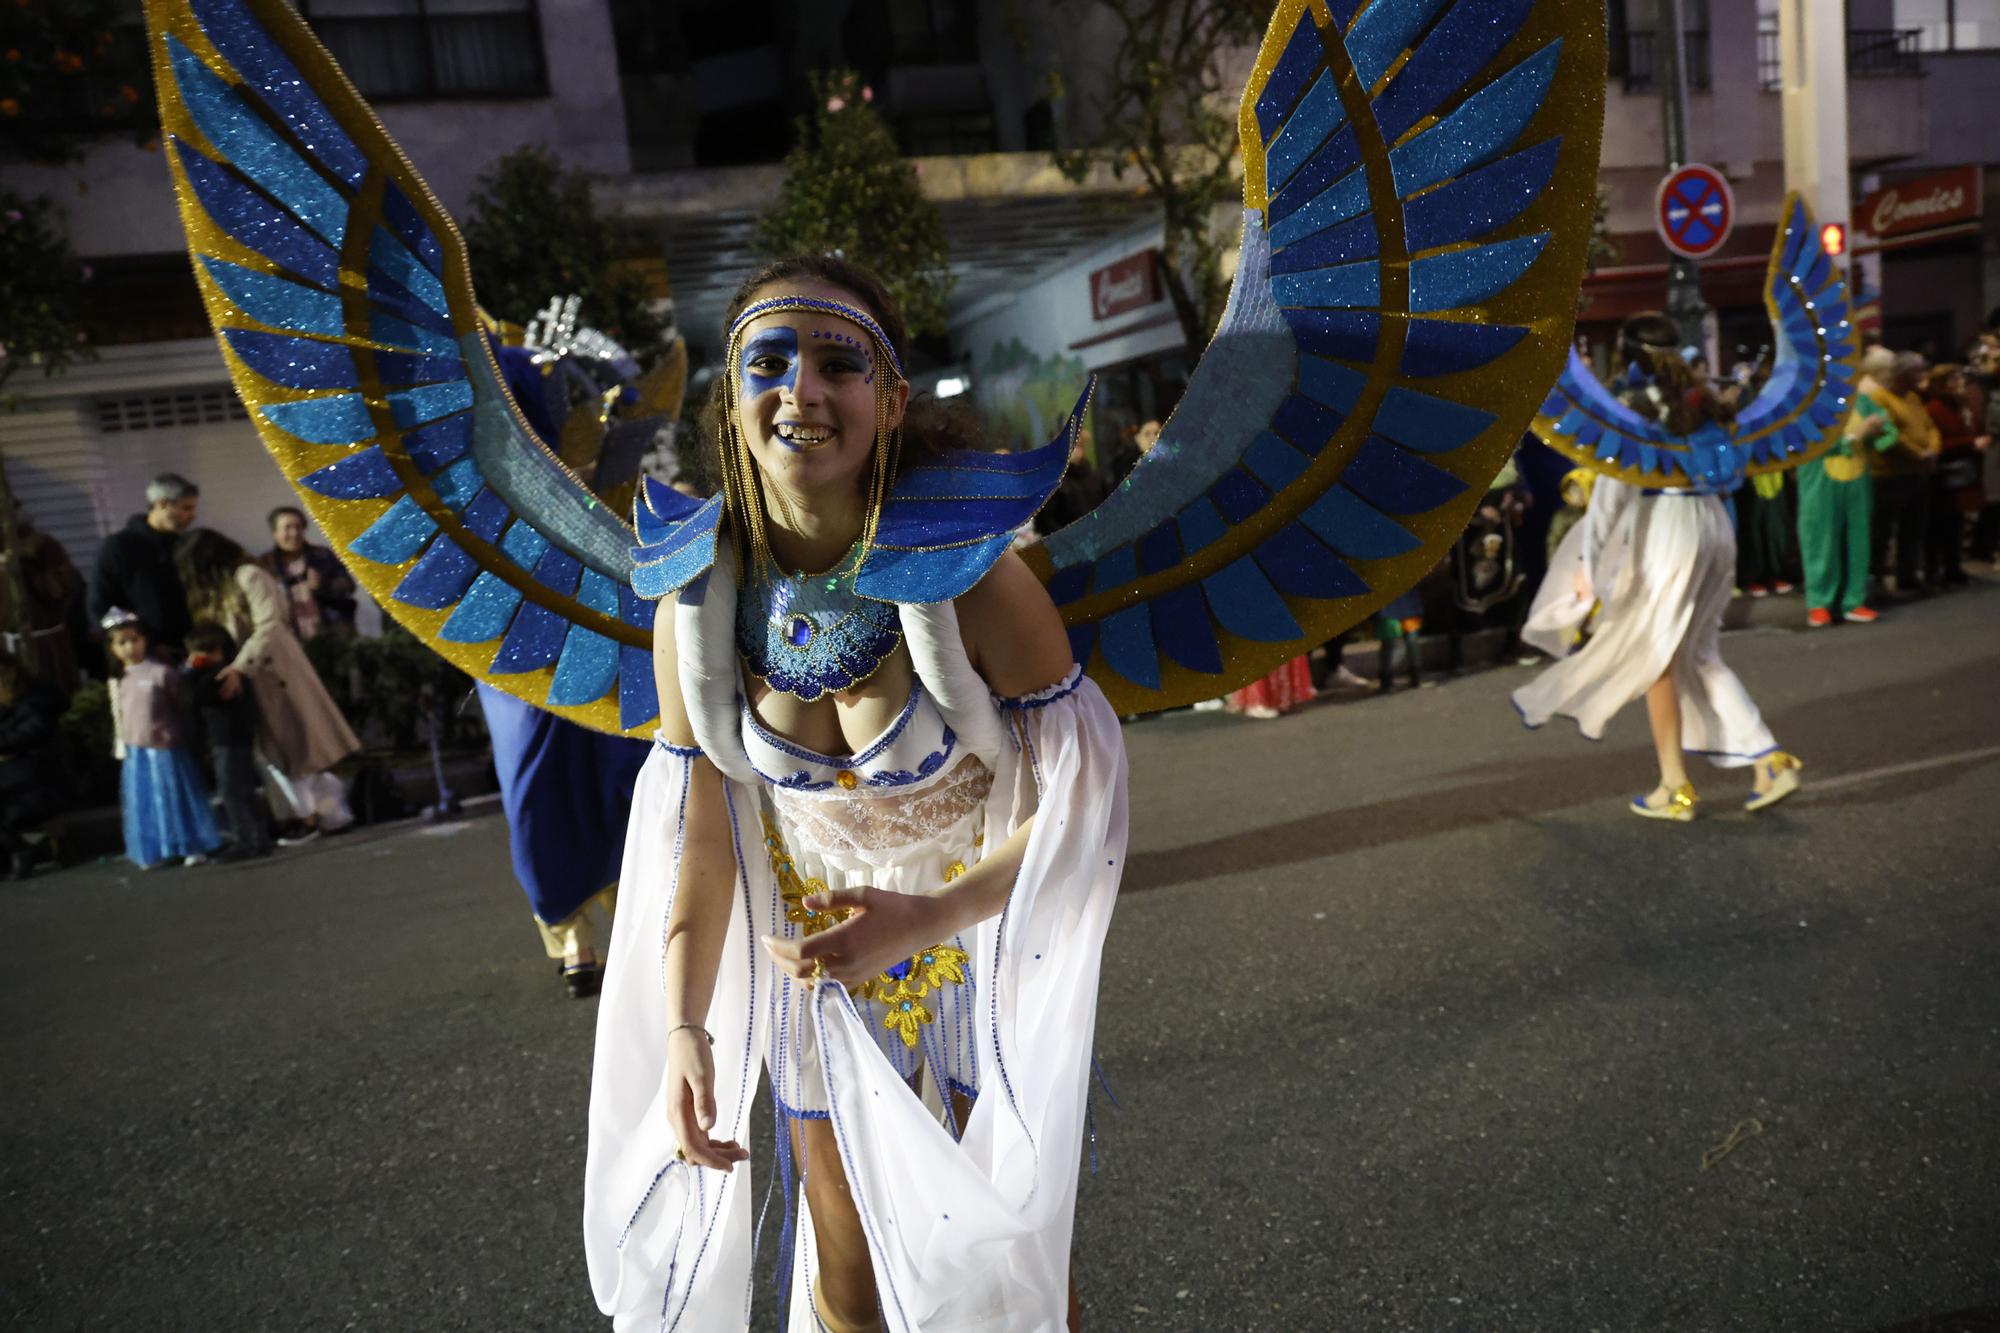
[{"left": 464, "top": 144, "right": 666, "bottom": 362}]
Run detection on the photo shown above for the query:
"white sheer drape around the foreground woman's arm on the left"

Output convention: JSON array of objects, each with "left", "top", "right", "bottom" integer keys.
[{"left": 584, "top": 743, "right": 776, "bottom": 1333}]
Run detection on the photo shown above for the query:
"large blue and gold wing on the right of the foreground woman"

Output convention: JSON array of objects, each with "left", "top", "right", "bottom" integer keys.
[{"left": 1026, "top": 0, "right": 1604, "bottom": 713}]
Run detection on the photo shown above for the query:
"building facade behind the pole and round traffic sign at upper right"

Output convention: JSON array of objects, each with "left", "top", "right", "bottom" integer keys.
[{"left": 1578, "top": 0, "right": 2000, "bottom": 364}]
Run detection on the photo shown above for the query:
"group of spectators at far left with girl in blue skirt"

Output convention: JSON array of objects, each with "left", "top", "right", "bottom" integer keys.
[{"left": 0, "top": 472, "right": 360, "bottom": 879}]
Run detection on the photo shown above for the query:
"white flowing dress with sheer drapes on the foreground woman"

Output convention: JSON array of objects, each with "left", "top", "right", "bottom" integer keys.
[{"left": 584, "top": 562, "right": 1126, "bottom": 1333}]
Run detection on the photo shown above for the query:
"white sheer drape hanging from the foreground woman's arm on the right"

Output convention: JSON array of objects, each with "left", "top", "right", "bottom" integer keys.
[{"left": 814, "top": 673, "right": 1126, "bottom": 1333}]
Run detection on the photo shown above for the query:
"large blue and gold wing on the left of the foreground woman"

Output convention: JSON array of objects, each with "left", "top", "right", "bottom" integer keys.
[{"left": 146, "top": 0, "right": 658, "bottom": 733}]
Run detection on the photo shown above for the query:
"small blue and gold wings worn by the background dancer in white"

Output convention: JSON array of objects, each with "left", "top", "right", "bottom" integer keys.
[{"left": 1534, "top": 194, "right": 1860, "bottom": 490}]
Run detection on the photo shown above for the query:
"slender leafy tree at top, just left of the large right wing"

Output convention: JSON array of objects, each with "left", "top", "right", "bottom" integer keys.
[{"left": 1048, "top": 0, "right": 1270, "bottom": 348}]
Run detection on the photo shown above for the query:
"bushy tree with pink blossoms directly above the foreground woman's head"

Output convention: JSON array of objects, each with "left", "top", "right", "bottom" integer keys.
[{"left": 756, "top": 70, "right": 952, "bottom": 336}]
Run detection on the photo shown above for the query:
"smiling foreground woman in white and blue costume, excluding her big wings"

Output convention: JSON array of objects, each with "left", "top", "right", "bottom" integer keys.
[{"left": 586, "top": 258, "right": 1126, "bottom": 1331}]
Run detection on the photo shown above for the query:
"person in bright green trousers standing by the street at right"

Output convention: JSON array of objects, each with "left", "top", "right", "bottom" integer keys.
[{"left": 1798, "top": 346, "right": 1896, "bottom": 628}]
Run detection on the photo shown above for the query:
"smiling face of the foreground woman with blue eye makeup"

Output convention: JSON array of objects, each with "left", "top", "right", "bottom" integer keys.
[{"left": 736, "top": 282, "right": 910, "bottom": 496}]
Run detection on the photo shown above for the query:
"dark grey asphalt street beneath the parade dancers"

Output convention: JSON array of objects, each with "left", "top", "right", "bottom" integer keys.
[{"left": 0, "top": 584, "right": 2000, "bottom": 1333}]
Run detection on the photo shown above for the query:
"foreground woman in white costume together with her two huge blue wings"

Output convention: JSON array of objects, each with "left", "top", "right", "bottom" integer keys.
[{"left": 148, "top": 0, "right": 1604, "bottom": 1312}]
